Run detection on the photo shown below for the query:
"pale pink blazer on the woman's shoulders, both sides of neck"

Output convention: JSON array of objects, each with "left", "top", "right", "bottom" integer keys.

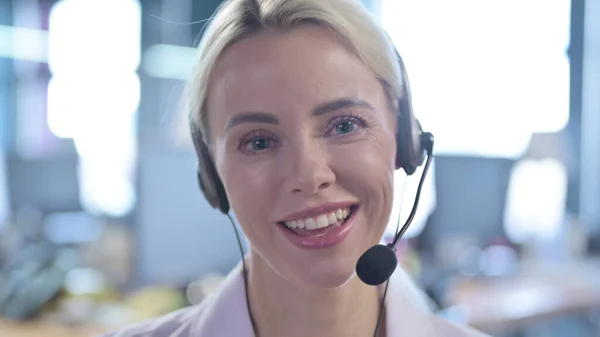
[{"left": 100, "top": 265, "right": 487, "bottom": 337}]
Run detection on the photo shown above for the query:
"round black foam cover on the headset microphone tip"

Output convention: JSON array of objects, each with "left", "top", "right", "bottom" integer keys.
[{"left": 356, "top": 245, "right": 398, "bottom": 286}]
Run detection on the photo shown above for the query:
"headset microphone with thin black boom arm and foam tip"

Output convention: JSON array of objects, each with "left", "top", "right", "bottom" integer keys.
[{"left": 356, "top": 132, "right": 433, "bottom": 286}]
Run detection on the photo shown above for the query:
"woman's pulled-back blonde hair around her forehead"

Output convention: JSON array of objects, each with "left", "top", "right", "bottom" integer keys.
[{"left": 186, "top": 0, "right": 402, "bottom": 143}]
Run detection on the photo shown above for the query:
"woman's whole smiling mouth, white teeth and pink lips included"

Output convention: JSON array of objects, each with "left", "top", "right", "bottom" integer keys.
[{"left": 278, "top": 204, "right": 359, "bottom": 249}]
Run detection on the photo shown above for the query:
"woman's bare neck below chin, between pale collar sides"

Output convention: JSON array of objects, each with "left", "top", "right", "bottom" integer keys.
[{"left": 248, "top": 253, "right": 385, "bottom": 337}]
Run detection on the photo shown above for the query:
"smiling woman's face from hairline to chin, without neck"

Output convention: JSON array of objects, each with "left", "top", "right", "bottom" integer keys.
[{"left": 207, "top": 25, "right": 396, "bottom": 288}]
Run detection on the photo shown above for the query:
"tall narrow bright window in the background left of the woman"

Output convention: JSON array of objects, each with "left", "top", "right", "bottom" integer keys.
[{"left": 48, "top": 0, "right": 141, "bottom": 216}]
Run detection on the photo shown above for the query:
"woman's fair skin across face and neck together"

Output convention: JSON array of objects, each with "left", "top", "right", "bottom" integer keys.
[{"left": 207, "top": 25, "right": 396, "bottom": 337}]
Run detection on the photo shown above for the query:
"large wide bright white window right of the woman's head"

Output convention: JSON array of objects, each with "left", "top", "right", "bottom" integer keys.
[{"left": 381, "top": 0, "right": 571, "bottom": 158}]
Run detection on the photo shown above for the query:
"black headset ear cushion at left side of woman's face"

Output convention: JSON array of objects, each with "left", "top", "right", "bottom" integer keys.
[{"left": 190, "top": 121, "right": 229, "bottom": 214}]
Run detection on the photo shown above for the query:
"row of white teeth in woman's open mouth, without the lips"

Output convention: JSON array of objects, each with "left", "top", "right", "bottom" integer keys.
[{"left": 279, "top": 205, "right": 358, "bottom": 237}]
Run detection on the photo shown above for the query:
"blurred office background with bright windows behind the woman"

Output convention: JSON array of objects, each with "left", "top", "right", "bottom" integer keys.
[{"left": 0, "top": 0, "right": 600, "bottom": 337}]
